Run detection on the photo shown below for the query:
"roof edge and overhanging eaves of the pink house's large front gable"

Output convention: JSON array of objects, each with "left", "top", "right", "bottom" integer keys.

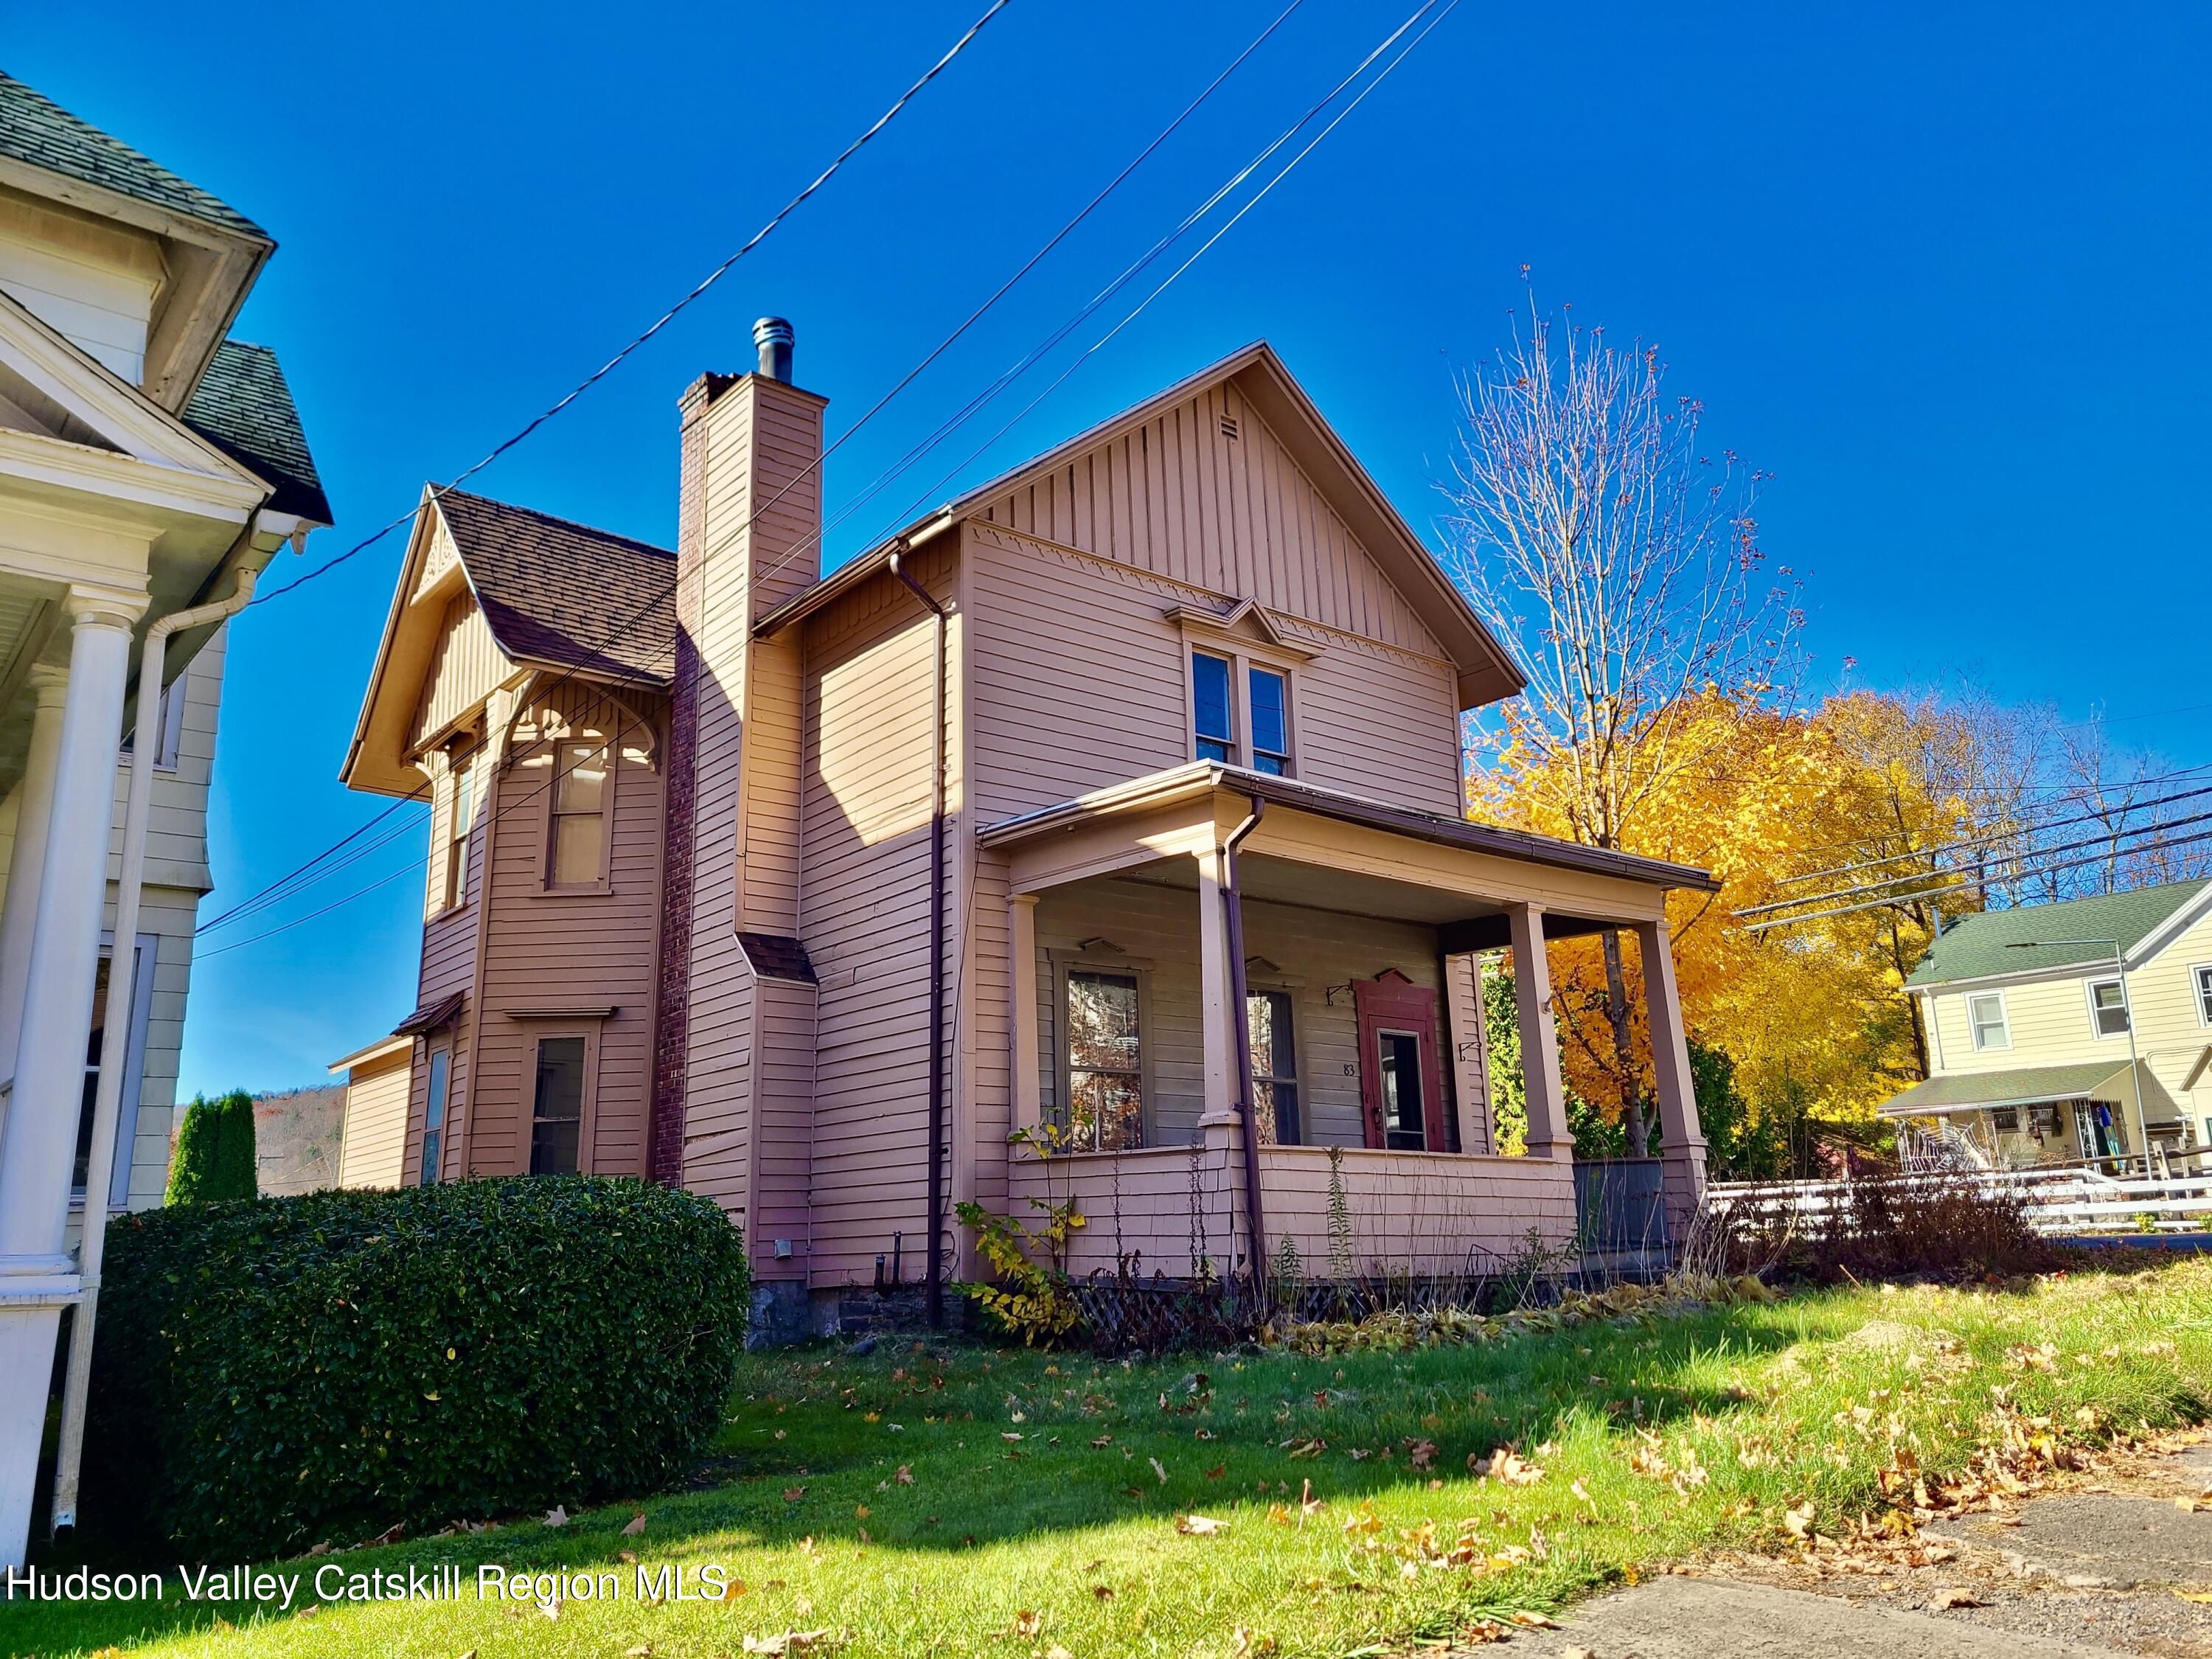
[{"left": 757, "top": 341, "right": 1526, "bottom": 708}]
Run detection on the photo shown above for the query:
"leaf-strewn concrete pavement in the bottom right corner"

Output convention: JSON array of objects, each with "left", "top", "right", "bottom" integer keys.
[{"left": 1513, "top": 1444, "right": 2212, "bottom": 1659}]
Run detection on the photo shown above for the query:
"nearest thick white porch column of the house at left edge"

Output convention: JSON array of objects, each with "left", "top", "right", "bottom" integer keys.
[{"left": 0, "top": 588, "right": 144, "bottom": 1566}]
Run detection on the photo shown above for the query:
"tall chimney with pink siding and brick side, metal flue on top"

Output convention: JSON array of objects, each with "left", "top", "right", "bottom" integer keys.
[{"left": 653, "top": 316, "right": 827, "bottom": 1194}]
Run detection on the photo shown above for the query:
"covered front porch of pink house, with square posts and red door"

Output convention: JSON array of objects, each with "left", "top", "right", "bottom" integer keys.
[{"left": 980, "top": 763, "right": 1710, "bottom": 1279}]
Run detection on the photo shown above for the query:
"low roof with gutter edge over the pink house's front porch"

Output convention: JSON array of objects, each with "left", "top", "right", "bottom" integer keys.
[{"left": 975, "top": 761, "right": 1721, "bottom": 894}]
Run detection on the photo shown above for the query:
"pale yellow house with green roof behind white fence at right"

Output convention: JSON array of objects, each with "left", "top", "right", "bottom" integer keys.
[{"left": 1882, "top": 880, "right": 2212, "bottom": 1172}]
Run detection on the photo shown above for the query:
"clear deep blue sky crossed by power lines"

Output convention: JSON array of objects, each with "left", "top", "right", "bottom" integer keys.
[{"left": 4, "top": 0, "right": 2212, "bottom": 1093}]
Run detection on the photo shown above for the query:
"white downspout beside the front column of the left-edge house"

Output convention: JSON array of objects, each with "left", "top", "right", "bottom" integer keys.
[{"left": 53, "top": 566, "right": 259, "bottom": 1528}]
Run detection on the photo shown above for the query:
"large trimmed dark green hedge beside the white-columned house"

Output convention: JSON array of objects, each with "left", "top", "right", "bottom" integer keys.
[{"left": 86, "top": 1177, "right": 748, "bottom": 1562}]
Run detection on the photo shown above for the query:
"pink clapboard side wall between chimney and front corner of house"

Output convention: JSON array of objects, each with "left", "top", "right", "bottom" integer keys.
[{"left": 799, "top": 549, "right": 967, "bottom": 1285}]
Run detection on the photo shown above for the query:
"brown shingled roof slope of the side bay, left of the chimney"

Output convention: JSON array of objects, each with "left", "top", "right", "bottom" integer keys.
[{"left": 436, "top": 489, "right": 677, "bottom": 686}]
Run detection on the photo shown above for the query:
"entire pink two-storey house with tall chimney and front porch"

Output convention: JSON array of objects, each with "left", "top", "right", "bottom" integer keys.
[{"left": 345, "top": 319, "right": 1712, "bottom": 1332}]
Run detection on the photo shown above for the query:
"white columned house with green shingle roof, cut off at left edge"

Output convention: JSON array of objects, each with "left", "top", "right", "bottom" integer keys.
[{"left": 0, "top": 73, "right": 330, "bottom": 1566}]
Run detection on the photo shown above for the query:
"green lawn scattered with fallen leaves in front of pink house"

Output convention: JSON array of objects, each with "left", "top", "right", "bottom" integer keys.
[{"left": 0, "top": 1259, "right": 2212, "bottom": 1659}]
